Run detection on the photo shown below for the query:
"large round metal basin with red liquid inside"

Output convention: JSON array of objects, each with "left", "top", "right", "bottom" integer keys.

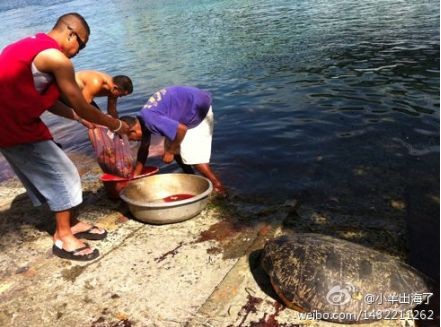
[{"left": 120, "top": 174, "right": 213, "bottom": 224}]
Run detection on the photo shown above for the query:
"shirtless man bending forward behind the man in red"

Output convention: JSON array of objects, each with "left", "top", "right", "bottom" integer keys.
[{"left": 75, "top": 70, "right": 133, "bottom": 118}]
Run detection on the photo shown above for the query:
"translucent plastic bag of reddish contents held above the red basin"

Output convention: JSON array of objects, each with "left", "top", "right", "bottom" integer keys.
[{"left": 89, "top": 126, "right": 135, "bottom": 178}]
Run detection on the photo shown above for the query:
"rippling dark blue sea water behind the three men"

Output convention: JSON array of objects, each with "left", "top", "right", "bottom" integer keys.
[{"left": 0, "top": 0, "right": 440, "bottom": 204}]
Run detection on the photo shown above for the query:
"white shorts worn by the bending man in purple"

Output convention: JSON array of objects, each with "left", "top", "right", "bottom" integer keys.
[{"left": 165, "top": 106, "right": 214, "bottom": 165}]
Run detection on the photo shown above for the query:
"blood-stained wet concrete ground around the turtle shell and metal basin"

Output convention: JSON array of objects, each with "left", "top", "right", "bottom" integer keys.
[{"left": 0, "top": 169, "right": 434, "bottom": 327}]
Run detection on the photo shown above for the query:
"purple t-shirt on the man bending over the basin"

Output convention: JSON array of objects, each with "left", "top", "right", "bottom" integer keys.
[{"left": 138, "top": 86, "right": 211, "bottom": 140}]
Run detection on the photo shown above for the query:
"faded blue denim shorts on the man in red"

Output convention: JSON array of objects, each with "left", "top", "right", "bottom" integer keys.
[{"left": 0, "top": 140, "right": 83, "bottom": 211}]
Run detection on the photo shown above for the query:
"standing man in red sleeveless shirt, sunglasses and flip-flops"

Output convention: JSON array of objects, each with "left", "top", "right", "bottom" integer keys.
[{"left": 0, "top": 13, "right": 129, "bottom": 261}]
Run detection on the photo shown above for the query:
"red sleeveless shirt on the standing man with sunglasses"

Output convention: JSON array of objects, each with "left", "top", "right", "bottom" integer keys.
[{"left": 0, "top": 33, "right": 60, "bottom": 148}]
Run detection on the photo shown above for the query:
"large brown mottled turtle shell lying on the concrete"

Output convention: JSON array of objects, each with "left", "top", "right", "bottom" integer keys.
[{"left": 261, "top": 233, "right": 432, "bottom": 323}]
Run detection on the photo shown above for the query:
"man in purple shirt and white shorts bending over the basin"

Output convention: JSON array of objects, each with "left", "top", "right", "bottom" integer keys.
[{"left": 121, "top": 86, "right": 227, "bottom": 196}]
